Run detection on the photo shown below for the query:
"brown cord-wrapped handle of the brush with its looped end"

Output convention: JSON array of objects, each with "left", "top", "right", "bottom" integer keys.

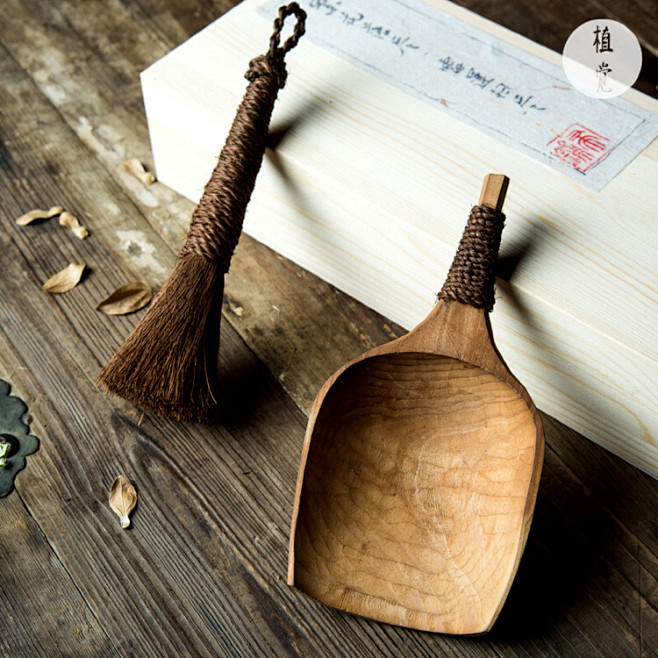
[{"left": 180, "top": 2, "right": 306, "bottom": 272}]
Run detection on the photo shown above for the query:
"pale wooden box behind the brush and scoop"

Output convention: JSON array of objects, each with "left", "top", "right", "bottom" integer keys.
[{"left": 142, "top": 0, "right": 658, "bottom": 476}]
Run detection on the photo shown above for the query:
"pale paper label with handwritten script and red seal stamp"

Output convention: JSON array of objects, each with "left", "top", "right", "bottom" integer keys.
[{"left": 259, "top": 0, "right": 658, "bottom": 191}]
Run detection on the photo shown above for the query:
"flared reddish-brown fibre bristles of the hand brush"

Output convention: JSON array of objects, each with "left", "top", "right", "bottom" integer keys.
[{"left": 99, "top": 255, "right": 224, "bottom": 422}]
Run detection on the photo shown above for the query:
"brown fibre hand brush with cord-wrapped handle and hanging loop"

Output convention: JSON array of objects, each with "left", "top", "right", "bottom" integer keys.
[{"left": 99, "top": 2, "right": 306, "bottom": 421}]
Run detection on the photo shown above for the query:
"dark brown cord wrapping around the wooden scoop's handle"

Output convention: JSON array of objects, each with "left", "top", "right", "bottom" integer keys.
[{"left": 438, "top": 206, "right": 505, "bottom": 311}]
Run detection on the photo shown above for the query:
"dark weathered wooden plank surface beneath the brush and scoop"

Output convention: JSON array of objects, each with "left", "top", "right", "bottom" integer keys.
[{"left": 0, "top": 0, "right": 658, "bottom": 657}]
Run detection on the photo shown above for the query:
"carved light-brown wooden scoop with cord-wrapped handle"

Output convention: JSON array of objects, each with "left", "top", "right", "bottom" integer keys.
[{"left": 288, "top": 174, "right": 544, "bottom": 634}]
